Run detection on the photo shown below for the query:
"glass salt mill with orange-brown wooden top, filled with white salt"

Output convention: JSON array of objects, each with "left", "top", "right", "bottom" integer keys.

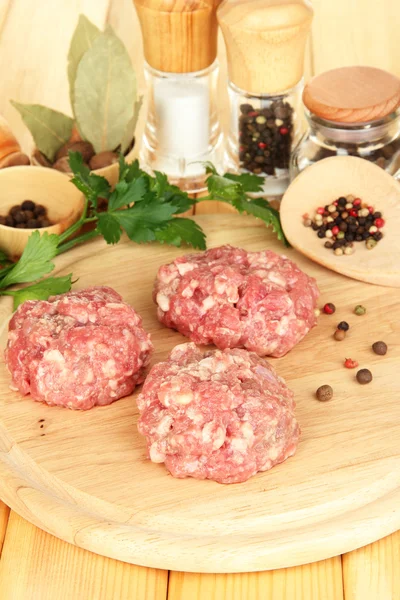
[{"left": 134, "top": 0, "right": 222, "bottom": 192}]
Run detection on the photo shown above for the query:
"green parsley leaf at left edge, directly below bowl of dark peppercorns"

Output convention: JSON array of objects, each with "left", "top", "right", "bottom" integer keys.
[{"left": 0, "top": 231, "right": 59, "bottom": 288}]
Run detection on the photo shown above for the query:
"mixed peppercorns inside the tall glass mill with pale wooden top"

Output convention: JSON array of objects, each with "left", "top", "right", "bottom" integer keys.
[{"left": 239, "top": 100, "right": 293, "bottom": 175}]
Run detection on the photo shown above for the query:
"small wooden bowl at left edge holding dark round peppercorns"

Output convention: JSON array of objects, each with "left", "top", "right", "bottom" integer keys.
[{"left": 0, "top": 166, "right": 84, "bottom": 258}]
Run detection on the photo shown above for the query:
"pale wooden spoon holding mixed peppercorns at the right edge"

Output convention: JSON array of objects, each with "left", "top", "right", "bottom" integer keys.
[{"left": 281, "top": 156, "right": 400, "bottom": 287}]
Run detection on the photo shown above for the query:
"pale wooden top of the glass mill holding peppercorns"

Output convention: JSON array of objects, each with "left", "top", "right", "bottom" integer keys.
[{"left": 217, "top": 0, "right": 313, "bottom": 94}]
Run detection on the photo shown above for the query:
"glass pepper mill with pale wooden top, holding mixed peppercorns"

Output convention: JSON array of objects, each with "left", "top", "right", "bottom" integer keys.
[{"left": 217, "top": 0, "right": 313, "bottom": 197}]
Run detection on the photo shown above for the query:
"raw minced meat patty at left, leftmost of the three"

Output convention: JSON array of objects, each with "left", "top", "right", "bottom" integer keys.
[{"left": 5, "top": 287, "right": 153, "bottom": 410}]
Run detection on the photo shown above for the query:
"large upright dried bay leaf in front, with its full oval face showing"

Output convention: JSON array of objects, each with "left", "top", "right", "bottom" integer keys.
[{"left": 73, "top": 28, "right": 136, "bottom": 153}]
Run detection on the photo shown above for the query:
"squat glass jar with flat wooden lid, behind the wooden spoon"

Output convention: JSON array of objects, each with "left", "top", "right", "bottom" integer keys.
[{"left": 290, "top": 67, "right": 400, "bottom": 179}]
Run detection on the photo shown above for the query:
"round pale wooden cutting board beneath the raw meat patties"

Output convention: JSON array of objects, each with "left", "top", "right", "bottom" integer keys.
[{"left": 0, "top": 215, "right": 400, "bottom": 572}]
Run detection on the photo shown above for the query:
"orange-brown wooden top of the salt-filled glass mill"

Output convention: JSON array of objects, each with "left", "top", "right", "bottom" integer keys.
[{"left": 133, "top": 0, "right": 221, "bottom": 73}]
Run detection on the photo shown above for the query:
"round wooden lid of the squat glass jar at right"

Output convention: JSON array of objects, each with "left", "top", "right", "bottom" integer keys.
[{"left": 303, "top": 67, "right": 400, "bottom": 123}]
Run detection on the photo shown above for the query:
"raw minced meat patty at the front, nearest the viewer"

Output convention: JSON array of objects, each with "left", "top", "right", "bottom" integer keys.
[{"left": 137, "top": 344, "right": 300, "bottom": 483}]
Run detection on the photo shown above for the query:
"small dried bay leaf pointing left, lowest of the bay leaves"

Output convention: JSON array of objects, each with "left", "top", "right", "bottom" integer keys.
[{"left": 10, "top": 100, "right": 74, "bottom": 162}]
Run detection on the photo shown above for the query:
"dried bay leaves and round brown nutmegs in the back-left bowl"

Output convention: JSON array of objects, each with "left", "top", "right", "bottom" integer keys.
[{"left": 11, "top": 15, "right": 142, "bottom": 185}]
